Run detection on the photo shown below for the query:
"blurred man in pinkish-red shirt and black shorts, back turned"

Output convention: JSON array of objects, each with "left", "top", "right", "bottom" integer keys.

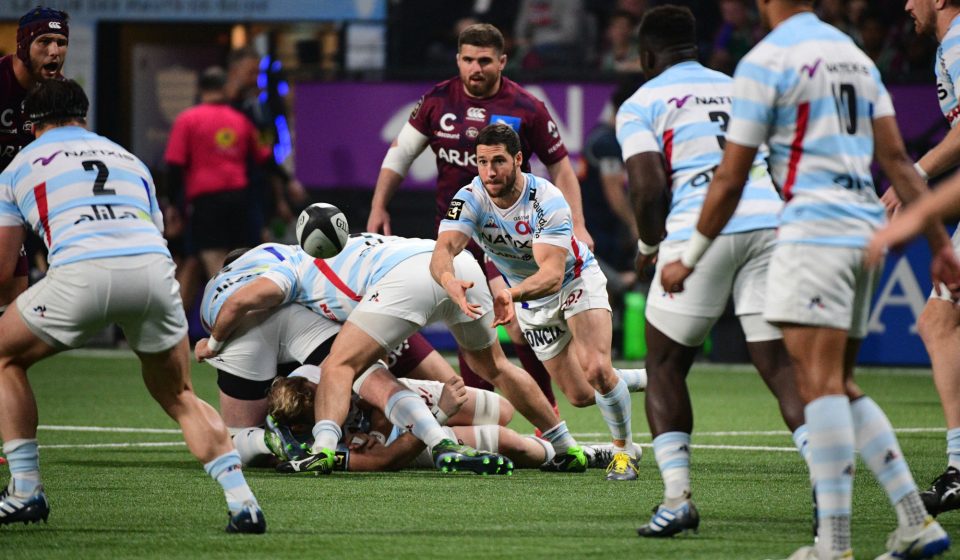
[{"left": 164, "top": 67, "right": 269, "bottom": 310}]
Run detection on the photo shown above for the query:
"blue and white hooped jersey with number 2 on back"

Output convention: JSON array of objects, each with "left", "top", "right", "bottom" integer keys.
[{"left": 0, "top": 126, "right": 170, "bottom": 267}]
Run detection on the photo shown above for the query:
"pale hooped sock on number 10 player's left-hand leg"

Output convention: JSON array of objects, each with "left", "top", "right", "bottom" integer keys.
[{"left": 804, "top": 395, "right": 854, "bottom": 558}]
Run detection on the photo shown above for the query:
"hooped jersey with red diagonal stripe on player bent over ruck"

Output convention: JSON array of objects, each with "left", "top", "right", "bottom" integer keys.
[{"left": 264, "top": 233, "right": 436, "bottom": 323}]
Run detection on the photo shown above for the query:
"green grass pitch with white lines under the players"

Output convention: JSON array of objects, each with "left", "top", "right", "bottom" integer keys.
[{"left": 0, "top": 353, "right": 960, "bottom": 560}]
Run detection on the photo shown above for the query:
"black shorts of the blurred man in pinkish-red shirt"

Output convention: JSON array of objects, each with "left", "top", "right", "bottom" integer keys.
[{"left": 187, "top": 189, "right": 255, "bottom": 255}]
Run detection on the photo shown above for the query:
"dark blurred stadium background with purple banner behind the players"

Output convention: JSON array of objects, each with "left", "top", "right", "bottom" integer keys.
[{"left": 0, "top": 0, "right": 946, "bottom": 365}]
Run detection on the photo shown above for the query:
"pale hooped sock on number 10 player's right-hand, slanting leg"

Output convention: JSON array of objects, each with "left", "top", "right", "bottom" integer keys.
[{"left": 850, "top": 397, "right": 927, "bottom": 527}]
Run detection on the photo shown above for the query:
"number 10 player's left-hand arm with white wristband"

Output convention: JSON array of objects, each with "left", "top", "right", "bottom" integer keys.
[{"left": 660, "top": 138, "right": 757, "bottom": 292}]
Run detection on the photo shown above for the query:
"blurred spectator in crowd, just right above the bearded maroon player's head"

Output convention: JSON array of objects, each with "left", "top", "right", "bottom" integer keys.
[{"left": 513, "top": 0, "right": 596, "bottom": 70}]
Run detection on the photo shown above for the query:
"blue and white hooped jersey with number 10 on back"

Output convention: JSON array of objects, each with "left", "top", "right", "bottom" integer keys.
[{"left": 727, "top": 12, "right": 894, "bottom": 247}]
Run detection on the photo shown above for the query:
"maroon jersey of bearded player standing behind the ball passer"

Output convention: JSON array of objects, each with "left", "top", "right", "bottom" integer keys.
[{"left": 410, "top": 77, "right": 567, "bottom": 226}]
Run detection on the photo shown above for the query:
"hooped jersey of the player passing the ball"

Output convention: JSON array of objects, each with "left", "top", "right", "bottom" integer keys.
[{"left": 439, "top": 173, "right": 596, "bottom": 307}]
